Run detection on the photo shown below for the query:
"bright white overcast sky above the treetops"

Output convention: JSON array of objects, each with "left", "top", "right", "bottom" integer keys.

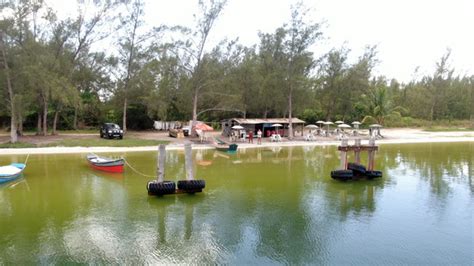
[{"left": 49, "top": 0, "right": 474, "bottom": 82}]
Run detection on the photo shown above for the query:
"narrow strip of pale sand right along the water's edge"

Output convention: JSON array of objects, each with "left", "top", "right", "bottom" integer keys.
[{"left": 0, "top": 136, "right": 474, "bottom": 155}]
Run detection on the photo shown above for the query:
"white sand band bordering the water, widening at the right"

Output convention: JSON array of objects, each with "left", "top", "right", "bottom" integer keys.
[{"left": 0, "top": 129, "right": 474, "bottom": 155}]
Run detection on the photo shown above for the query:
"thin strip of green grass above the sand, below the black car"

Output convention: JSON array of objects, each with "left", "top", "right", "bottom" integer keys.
[{"left": 42, "top": 138, "right": 169, "bottom": 147}]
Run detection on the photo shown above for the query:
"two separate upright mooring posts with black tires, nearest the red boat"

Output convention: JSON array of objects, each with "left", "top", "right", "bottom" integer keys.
[{"left": 147, "top": 144, "right": 206, "bottom": 196}]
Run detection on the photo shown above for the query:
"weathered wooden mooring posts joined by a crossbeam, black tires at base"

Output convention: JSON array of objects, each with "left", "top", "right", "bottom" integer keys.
[{"left": 331, "top": 138, "right": 382, "bottom": 181}]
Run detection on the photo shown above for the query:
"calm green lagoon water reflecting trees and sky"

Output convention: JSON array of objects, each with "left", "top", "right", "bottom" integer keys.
[{"left": 0, "top": 142, "right": 474, "bottom": 265}]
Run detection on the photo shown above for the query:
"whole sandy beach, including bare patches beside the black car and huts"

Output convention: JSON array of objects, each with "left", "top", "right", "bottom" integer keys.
[{"left": 0, "top": 129, "right": 474, "bottom": 155}]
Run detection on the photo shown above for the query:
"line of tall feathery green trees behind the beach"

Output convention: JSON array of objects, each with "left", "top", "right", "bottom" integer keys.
[{"left": 0, "top": 0, "right": 474, "bottom": 142}]
